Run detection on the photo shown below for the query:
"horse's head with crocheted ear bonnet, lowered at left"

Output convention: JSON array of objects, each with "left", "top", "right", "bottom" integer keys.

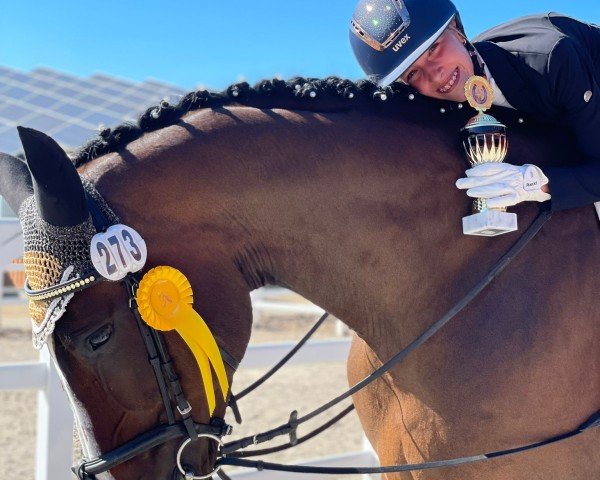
[{"left": 0, "top": 128, "right": 231, "bottom": 480}]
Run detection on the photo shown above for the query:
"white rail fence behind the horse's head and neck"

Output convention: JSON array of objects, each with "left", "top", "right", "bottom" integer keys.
[{"left": 0, "top": 292, "right": 377, "bottom": 480}]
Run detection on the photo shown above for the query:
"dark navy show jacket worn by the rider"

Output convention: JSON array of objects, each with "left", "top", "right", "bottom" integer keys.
[{"left": 473, "top": 13, "right": 600, "bottom": 211}]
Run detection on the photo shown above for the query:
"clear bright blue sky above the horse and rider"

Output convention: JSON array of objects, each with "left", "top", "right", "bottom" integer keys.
[{"left": 0, "top": 0, "right": 600, "bottom": 89}]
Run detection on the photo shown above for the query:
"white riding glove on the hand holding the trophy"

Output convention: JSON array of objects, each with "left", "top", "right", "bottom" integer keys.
[{"left": 456, "top": 163, "right": 550, "bottom": 208}]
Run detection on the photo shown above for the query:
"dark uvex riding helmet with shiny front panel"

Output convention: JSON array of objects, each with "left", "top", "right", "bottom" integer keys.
[{"left": 350, "top": 0, "right": 464, "bottom": 87}]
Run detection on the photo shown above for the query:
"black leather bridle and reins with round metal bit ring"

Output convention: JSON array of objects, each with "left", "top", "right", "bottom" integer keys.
[{"left": 26, "top": 189, "right": 600, "bottom": 480}]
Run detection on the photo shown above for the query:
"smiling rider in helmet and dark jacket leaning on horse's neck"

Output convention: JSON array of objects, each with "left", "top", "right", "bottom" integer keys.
[{"left": 350, "top": 0, "right": 600, "bottom": 217}]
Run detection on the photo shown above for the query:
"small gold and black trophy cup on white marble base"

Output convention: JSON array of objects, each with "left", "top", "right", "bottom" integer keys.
[{"left": 460, "top": 76, "right": 517, "bottom": 237}]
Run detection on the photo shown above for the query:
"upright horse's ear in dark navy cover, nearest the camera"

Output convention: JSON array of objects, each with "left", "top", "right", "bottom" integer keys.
[{"left": 17, "top": 127, "right": 88, "bottom": 227}]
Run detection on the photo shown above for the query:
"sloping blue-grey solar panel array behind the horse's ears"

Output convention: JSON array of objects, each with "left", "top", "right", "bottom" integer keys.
[{"left": 0, "top": 65, "right": 187, "bottom": 154}]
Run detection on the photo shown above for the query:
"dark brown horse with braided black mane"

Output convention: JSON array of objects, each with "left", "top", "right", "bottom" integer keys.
[{"left": 0, "top": 78, "right": 600, "bottom": 480}]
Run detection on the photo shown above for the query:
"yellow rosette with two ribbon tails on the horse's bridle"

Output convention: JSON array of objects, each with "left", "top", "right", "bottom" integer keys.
[{"left": 136, "top": 266, "right": 229, "bottom": 415}]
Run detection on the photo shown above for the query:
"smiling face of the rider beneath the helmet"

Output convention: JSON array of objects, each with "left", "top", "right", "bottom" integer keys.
[{"left": 400, "top": 28, "right": 473, "bottom": 102}]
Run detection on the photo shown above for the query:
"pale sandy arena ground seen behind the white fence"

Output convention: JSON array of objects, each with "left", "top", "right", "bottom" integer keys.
[{"left": 0, "top": 294, "right": 376, "bottom": 480}]
